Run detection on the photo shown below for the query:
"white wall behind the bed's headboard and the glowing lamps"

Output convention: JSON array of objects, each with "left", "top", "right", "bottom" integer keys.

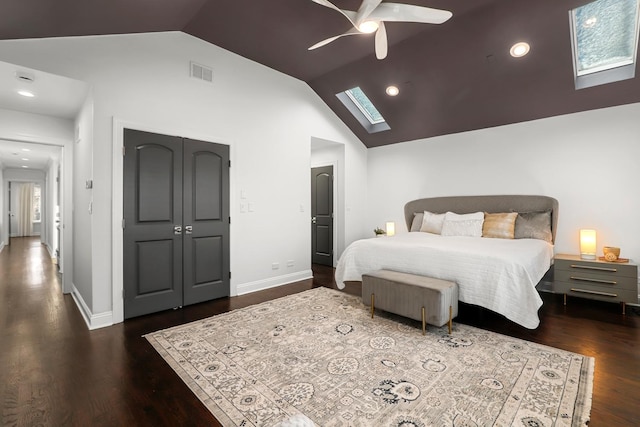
[{"left": 367, "top": 104, "right": 640, "bottom": 262}]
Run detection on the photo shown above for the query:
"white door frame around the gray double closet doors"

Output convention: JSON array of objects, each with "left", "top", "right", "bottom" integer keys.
[{"left": 111, "top": 116, "right": 238, "bottom": 324}]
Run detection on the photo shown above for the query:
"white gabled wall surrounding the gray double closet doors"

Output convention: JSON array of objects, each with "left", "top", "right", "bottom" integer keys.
[{"left": 0, "top": 32, "right": 367, "bottom": 319}]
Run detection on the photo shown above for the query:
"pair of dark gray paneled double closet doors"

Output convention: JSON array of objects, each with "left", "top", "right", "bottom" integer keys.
[{"left": 123, "top": 129, "right": 230, "bottom": 319}]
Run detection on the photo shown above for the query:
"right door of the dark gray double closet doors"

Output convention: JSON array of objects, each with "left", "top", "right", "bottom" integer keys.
[{"left": 183, "top": 139, "right": 229, "bottom": 305}]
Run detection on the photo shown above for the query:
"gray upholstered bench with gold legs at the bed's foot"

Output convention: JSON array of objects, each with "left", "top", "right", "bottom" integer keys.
[{"left": 362, "top": 270, "right": 458, "bottom": 335}]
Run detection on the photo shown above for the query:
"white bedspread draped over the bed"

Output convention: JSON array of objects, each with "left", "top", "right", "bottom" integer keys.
[{"left": 336, "top": 232, "right": 553, "bottom": 329}]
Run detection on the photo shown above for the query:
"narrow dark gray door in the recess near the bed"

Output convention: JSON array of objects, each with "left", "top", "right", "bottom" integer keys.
[{"left": 311, "top": 166, "right": 333, "bottom": 266}]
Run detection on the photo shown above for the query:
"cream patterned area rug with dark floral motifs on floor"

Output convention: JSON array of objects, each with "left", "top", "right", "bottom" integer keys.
[{"left": 146, "top": 288, "right": 594, "bottom": 427}]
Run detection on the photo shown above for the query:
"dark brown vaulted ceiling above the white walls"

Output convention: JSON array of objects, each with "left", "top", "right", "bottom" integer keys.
[{"left": 0, "top": 0, "right": 640, "bottom": 147}]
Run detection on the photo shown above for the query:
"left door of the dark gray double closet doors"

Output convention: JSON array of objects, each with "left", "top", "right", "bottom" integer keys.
[{"left": 123, "top": 129, "right": 182, "bottom": 318}]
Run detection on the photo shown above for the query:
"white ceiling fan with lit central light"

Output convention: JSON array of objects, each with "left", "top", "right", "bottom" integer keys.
[{"left": 309, "top": 0, "right": 453, "bottom": 59}]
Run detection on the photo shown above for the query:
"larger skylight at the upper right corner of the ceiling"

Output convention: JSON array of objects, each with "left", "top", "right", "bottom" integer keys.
[{"left": 570, "top": 0, "right": 639, "bottom": 89}]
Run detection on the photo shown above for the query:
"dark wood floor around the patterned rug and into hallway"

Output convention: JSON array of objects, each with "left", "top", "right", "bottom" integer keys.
[{"left": 0, "top": 238, "right": 640, "bottom": 427}]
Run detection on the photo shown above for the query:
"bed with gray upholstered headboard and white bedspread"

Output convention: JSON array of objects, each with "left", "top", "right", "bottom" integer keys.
[{"left": 336, "top": 195, "right": 558, "bottom": 329}]
